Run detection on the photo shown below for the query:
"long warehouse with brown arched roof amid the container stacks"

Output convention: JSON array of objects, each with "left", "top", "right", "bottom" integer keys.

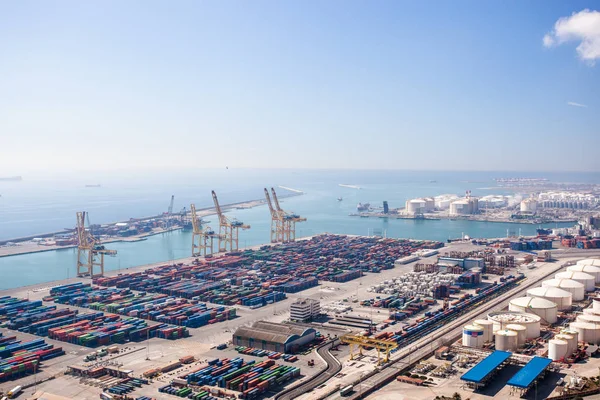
[{"left": 233, "top": 321, "right": 317, "bottom": 353}]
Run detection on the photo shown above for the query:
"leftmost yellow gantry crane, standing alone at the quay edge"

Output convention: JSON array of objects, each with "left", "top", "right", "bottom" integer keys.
[{"left": 77, "top": 211, "right": 117, "bottom": 277}]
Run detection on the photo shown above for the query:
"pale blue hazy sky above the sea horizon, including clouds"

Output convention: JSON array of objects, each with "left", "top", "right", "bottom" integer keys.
[{"left": 0, "top": 0, "right": 600, "bottom": 176}]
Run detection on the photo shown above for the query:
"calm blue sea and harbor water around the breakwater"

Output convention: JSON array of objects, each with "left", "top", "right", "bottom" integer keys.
[{"left": 0, "top": 169, "right": 584, "bottom": 289}]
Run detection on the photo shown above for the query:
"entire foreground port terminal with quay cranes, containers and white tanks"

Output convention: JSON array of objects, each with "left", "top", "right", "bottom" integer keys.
[{"left": 0, "top": 188, "right": 600, "bottom": 399}]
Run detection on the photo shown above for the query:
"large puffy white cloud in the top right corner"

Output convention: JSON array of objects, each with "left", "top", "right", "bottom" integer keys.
[{"left": 543, "top": 9, "right": 600, "bottom": 65}]
